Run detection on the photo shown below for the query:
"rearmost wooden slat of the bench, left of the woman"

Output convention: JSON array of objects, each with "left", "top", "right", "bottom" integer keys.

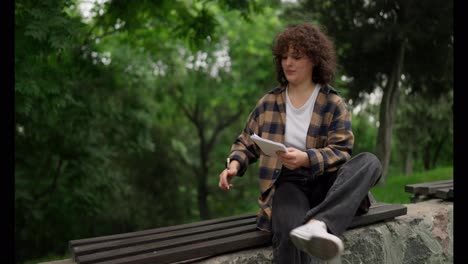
[{"left": 69, "top": 213, "right": 257, "bottom": 248}]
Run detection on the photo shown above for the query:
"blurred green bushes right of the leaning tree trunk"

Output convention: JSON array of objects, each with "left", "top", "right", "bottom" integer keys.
[{"left": 394, "top": 88, "right": 453, "bottom": 171}]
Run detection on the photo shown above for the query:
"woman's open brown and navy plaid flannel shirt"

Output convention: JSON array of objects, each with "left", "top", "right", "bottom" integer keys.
[{"left": 229, "top": 85, "right": 354, "bottom": 231}]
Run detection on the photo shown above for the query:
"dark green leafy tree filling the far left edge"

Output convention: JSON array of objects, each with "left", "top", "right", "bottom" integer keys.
[{"left": 15, "top": 1, "right": 132, "bottom": 261}]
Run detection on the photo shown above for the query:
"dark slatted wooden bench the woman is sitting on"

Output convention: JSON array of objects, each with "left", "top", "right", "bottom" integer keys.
[{"left": 69, "top": 200, "right": 407, "bottom": 264}]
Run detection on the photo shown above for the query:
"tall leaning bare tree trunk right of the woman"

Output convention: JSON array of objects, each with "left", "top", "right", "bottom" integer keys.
[{"left": 376, "top": 41, "right": 406, "bottom": 184}]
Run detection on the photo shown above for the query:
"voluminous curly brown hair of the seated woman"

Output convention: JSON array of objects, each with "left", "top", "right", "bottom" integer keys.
[{"left": 272, "top": 23, "right": 336, "bottom": 86}]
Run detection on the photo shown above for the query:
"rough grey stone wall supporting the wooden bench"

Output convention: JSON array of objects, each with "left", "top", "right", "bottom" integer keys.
[{"left": 191, "top": 199, "right": 453, "bottom": 264}]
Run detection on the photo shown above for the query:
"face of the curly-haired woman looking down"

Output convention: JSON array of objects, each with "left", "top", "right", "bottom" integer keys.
[{"left": 281, "top": 47, "right": 314, "bottom": 85}]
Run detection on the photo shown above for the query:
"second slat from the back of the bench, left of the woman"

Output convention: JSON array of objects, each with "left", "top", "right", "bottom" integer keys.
[{"left": 73, "top": 218, "right": 256, "bottom": 259}]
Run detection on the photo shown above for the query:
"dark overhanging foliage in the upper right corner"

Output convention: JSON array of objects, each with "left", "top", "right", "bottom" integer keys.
[{"left": 285, "top": 0, "right": 453, "bottom": 101}]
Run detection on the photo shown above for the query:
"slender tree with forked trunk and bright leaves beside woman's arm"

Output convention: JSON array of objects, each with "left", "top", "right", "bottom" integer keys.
[{"left": 154, "top": 6, "right": 280, "bottom": 219}]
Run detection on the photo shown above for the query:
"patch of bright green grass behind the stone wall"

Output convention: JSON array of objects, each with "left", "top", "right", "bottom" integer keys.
[{"left": 371, "top": 167, "right": 453, "bottom": 204}]
